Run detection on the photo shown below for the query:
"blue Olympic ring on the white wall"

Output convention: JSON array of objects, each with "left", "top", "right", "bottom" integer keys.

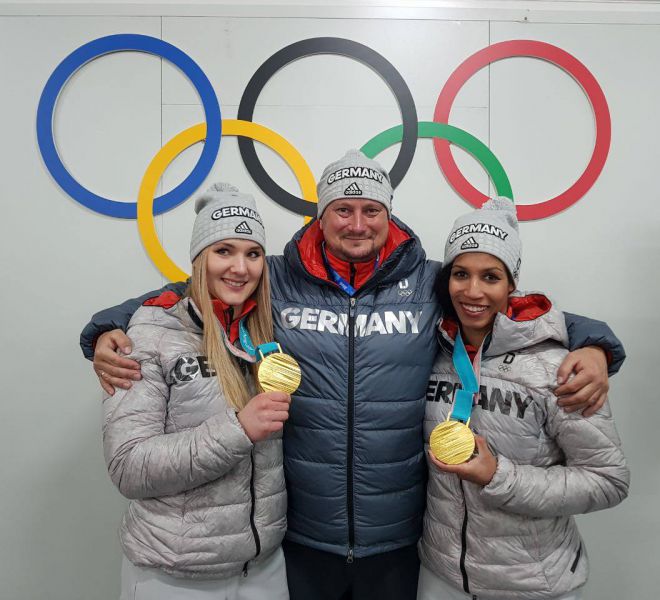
[{"left": 37, "top": 34, "right": 222, "bottom": 219}]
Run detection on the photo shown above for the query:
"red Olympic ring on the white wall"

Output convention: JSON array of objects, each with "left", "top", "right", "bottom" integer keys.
[{"left": 433, "top": 40, "right": 612, "bottom": 221}]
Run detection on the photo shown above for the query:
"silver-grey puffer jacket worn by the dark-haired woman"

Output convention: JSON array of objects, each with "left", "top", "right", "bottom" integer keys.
[{"left": 419, "top": 293, "right": 629, "bottom": 600}]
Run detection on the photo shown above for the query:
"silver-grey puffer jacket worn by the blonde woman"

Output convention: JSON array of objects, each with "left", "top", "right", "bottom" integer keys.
[{"left": 103, "top": 292, "right": 286, "bottom": 579}]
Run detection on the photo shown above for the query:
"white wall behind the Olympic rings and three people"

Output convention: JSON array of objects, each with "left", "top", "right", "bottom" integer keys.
[{"left": 0, "top": 2, "right": 660, "bottom": 600}]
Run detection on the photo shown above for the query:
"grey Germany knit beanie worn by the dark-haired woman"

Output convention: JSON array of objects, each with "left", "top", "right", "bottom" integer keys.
[{"left": 444, "top": 196, "right": 522, "bottom": 285}]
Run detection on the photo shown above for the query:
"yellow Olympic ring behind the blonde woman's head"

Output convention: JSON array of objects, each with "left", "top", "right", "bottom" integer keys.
[{"left": 137, "top": 119, "right": 318, "bottom": 281}]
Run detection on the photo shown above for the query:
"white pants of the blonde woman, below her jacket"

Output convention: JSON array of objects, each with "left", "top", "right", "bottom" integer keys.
[{"left": 119, "top": 548, "right": 289, "bottom": 600}]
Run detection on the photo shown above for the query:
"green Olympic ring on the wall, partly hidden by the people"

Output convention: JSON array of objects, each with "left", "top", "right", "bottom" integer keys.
[{"left": 360, "top": 121, "right": 513, "bottom": 200}]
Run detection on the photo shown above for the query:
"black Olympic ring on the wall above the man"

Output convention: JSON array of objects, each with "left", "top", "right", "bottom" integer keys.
[{"left": 238, "top": 37, "right": 417, "bottom": 217}]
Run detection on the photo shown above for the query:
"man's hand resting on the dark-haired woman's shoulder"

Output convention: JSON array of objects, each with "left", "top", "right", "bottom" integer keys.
[{"left": 555, "top": 346, "right": 610, "bottom": 417}]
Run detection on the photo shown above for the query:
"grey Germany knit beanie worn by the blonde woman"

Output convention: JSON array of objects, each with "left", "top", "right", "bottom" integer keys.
[{"left": 190, "top": 182, "right": 266, "bottom": 261}]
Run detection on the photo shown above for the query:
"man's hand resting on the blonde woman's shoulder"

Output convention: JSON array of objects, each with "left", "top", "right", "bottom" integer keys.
[{"left": 93, "top": 329, "right": 142, "bottom": 396}]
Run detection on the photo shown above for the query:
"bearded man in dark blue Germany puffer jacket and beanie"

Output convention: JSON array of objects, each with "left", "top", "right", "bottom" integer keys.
[{"left": 82, "top": 150, "right": 624, "bottom": 600}]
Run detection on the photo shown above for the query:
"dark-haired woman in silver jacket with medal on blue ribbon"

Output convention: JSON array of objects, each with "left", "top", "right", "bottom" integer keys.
[{"left": 418, "top": 198, "right": 629, "bottom": 600}]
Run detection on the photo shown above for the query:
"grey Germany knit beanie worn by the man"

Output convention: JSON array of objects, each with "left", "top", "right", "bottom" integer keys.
[{"left": 316, "top": 150, "right": 393, "bottom": 218}]
